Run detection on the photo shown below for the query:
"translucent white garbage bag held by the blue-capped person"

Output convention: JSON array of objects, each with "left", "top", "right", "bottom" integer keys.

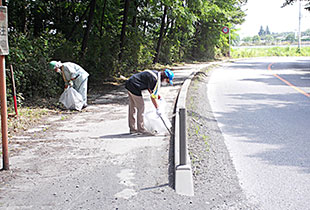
[{"left": 144, "top": 98, "right": 171, "bottom": 134}]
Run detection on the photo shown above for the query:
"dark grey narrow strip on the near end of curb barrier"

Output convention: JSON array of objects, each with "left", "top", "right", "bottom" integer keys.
[{"left": 179, "top": 108, "right": 187, "bottom": 165}]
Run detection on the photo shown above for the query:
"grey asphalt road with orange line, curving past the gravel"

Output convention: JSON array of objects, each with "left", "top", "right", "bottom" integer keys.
[{"left": 208, "top": 57, "right": 310, "bottom": 210}]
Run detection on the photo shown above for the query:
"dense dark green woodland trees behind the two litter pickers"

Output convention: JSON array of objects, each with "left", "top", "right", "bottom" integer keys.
[{"left": 7, "top": 0, "right": 246, "bottom": 101}]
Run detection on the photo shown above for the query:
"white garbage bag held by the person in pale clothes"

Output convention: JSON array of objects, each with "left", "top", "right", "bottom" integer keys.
[{"left": 59, "top": 87, "right": 84, "bottom": 111}]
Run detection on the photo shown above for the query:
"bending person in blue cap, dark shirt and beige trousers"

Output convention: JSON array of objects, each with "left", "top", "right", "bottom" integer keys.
[{"left": 125, "top": 69, "right": 174, "bottom": 134}]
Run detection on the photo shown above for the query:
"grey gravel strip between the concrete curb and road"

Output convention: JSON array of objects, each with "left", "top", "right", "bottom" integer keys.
[{"left": 186, "top": 69, "right": 258, "bottom": 209}]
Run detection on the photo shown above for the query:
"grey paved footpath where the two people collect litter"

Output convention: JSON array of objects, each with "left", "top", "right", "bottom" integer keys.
[{"left": 0, "top": 65, "right": 208, "bottom": 209}]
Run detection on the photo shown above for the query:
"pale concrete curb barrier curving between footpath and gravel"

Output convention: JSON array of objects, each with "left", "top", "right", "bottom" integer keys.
[{"left": 174, "top": 63, "right": 217, "bottom": 196}]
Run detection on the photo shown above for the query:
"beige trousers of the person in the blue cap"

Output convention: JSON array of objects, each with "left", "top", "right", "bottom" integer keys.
[{"left": 128, "top": 91, "right": 145, "bottom": 132}]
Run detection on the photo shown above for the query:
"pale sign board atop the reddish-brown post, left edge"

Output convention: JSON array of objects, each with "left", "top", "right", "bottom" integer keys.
[{"left": 0, "top": 6, "right": 9, "bottom": 55}]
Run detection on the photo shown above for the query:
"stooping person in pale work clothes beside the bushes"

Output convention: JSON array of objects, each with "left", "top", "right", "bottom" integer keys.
[{"left": 48, "top": 61, "right": 89, "bottom": 108}]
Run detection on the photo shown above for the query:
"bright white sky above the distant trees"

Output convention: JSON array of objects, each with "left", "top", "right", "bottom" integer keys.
[{"left": 235, "top": 0, "right": 310, "bottom": 38}]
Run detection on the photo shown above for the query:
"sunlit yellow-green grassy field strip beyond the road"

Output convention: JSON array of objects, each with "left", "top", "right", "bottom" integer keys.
[{"left": 231, "top": 46, "right": 310, "bottom": 58}]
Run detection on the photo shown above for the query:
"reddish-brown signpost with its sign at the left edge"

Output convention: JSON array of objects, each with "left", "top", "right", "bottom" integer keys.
[{"left": 0, "top": 0, "right": 9, "bottom": 170}]
